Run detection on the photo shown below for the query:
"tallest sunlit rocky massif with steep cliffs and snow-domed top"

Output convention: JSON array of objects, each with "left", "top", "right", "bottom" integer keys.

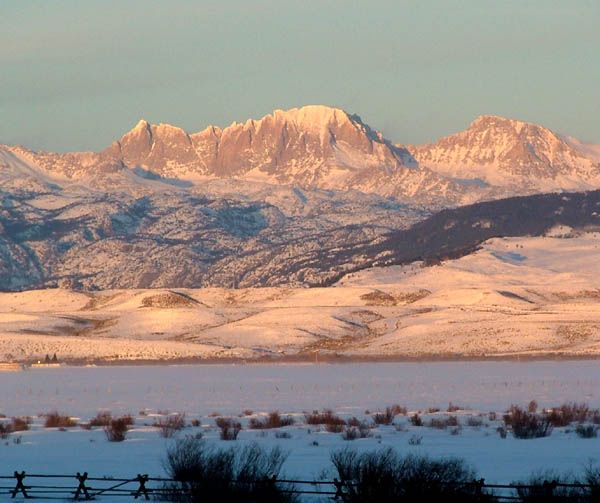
[{"left": 105, "top": 106, "right": 410, "bottom": 188}]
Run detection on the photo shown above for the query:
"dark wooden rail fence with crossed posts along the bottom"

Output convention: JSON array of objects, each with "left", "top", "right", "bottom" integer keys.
[{"left": 0, "top": 471, "right": 600, "bottom": 503}]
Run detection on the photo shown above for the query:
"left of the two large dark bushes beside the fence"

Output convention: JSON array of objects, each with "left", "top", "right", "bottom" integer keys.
[{"left": 165, "top": 438, "right": 297, "bottom": 503}]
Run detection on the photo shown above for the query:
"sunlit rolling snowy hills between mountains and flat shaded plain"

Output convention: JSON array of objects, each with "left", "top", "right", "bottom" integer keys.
[{"left": 0, "top": 232, "right": 600, "bottom": 361}]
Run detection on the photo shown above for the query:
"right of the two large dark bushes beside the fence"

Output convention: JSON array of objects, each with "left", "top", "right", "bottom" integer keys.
[{"left": 331, "top": 449, "right": 486, "bottom": 503}]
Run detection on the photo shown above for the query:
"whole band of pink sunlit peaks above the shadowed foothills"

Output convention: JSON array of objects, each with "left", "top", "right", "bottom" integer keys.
[{"left": 4, "top": 105, "right": 600, "bottom": 208}]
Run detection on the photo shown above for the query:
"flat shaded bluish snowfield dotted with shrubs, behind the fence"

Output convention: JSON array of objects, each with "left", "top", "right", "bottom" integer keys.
[{"left": 0, "top": 361, "right": 600, "bottom": 492}]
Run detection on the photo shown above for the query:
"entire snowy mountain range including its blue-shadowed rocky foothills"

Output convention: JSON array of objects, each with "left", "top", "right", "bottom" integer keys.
[{"left": 0, "top": 106, "right": 600, "bottom": 290}]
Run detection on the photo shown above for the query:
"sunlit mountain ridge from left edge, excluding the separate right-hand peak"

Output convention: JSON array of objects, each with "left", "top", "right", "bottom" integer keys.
[{"left": 4, "top": 106, "right": 496, "bottom": 207}]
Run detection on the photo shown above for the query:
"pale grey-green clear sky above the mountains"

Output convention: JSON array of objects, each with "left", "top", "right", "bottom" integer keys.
[{"left": 0, "top": 0, "right": 600, "bottom": 151}]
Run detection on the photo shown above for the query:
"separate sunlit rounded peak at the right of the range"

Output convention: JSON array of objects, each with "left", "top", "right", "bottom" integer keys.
[{"left": 407, "top": 115, "right": 600, "bottom": 193}]
